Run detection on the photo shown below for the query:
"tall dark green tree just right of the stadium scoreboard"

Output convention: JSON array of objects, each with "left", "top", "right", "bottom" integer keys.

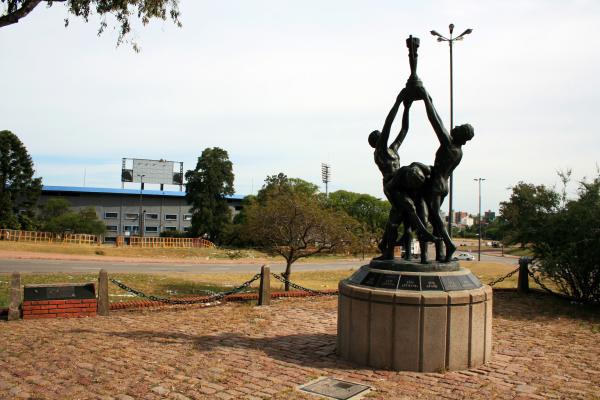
[{"left": 185, "top": 147, "right": 235, "bottom": 243}]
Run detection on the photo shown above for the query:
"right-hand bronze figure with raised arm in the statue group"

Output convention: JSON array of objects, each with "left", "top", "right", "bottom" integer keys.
[{"left": 417, "top": 87, "right": 474, "bottom": 262}]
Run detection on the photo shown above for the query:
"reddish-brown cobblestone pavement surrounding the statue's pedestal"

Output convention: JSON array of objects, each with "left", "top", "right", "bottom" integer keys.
[{"left": 0, "top": 292, "right": 600, "bottom": 400}]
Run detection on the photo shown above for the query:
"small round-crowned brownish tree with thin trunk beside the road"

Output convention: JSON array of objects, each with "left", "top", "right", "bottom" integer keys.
[{"left": 245, "top": 174, "right": 356, "bottom": 291}]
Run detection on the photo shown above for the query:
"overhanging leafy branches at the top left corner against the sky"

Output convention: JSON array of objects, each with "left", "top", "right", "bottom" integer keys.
[{"left": 0, "top": 0, "right": 181, "bottom": 51}]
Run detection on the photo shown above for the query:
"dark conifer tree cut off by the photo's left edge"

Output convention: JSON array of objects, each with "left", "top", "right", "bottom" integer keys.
[{"left": 0, "top": 131, "right": 42, "bottom": 229}]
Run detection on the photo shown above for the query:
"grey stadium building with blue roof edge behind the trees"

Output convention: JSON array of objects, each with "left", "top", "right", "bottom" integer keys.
[{"left": 39, "top": 186, "right": 244, "bottom": 241}]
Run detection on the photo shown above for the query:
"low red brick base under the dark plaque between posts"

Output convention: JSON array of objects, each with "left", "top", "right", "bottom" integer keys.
[{"left": 23, "top": 299, "right": 97, "bottom": 319}]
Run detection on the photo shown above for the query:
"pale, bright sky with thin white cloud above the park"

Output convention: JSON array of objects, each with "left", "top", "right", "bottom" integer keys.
[{"left": 0, "top": 0, "right": 600, "bottom": 213}]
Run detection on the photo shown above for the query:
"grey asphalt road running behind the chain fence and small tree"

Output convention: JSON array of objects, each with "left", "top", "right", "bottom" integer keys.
[{"left": 0, "top": 254, "right": 517, "bottom": 274}]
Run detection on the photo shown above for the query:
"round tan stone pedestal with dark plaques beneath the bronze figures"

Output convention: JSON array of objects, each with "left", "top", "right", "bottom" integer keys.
[{"left": 337, "top": 260, "right": 492, "bottom": 372}]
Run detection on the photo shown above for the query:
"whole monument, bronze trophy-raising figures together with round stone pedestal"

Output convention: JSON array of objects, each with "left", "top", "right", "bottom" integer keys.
[{"left": 337, "top": 36, "right": 492, "bottom": 372}]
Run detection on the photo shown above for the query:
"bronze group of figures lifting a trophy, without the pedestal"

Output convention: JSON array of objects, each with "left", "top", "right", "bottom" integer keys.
[{"left": 369, "top": 36, "right": 474, "bottom": 263}]
